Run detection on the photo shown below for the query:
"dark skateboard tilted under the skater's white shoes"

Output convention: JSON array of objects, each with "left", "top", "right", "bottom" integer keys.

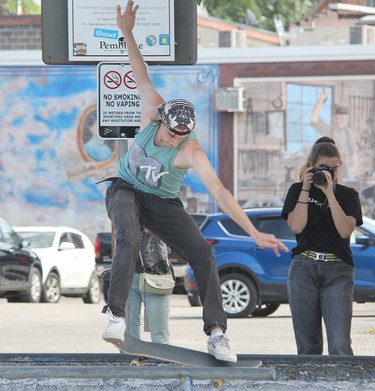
[{"left": 116, "top": 336, "right": 262, "bottom": 368}]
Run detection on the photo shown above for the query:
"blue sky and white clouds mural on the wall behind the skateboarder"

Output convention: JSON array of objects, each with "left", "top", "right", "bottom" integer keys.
[{"left": 0, "top": 65, "right": 218, "bottom": 239}]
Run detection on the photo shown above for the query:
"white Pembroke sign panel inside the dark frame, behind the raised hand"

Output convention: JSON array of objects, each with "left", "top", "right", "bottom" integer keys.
[{"left": 68, "top": 0, "right": 175, "bottom": 61}]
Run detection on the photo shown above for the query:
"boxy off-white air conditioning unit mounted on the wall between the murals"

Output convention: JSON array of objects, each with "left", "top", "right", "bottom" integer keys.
[{"left": 214, "top": 87, "right": 246, "bottom": 112}]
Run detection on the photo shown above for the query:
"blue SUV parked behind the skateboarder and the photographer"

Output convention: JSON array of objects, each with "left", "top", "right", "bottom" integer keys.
[{"left": 185, "top": 207, "right": 375, "bottom": 318}]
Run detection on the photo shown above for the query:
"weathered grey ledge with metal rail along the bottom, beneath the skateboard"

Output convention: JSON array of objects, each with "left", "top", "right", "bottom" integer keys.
[{"left": 0, "top": 354, "right": 375, "bottom": 391}]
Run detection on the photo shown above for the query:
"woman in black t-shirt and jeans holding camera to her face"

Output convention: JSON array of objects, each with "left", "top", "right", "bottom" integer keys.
[{"left": 282, "top": 137, "right": 362, "bottom": 355}]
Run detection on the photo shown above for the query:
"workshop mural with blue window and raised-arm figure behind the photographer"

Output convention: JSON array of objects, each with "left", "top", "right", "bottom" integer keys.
[{"left": 235, "top": 77, "right": 375, "bottom": 218}]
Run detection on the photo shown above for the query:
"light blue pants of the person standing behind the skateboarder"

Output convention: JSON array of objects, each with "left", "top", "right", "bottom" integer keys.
[{"left": 125, "top": 273, "right": 171, "bottom": 344}]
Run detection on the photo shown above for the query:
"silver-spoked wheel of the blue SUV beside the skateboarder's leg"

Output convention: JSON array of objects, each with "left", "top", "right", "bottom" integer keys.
[{"left": 220, "top": 273, "right": 257, "bottom": 318}]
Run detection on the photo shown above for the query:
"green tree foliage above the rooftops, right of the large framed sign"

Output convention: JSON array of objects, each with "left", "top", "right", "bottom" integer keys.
[{"left": 196, "top": 0, "right": 318, "bottom": 31}]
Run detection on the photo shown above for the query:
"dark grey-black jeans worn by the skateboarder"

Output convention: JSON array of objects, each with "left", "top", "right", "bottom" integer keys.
[{"left": 105, "top": 178, "right": 227, "bottom": 334}]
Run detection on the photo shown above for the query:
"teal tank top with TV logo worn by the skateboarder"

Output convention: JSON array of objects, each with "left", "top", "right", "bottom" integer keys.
[{"left": 118, "top": 122, "right": 198, "bottom": 198}]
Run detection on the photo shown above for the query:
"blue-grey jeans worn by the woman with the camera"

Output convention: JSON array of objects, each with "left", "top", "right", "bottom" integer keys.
[{"left": 288, "top": 254, "right": 354, "bottom": 355}]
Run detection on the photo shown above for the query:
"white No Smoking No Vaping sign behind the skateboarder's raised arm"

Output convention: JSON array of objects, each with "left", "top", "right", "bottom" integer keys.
[{"left": 98, "top": 62, "right": 141, "bottom": 140}]
